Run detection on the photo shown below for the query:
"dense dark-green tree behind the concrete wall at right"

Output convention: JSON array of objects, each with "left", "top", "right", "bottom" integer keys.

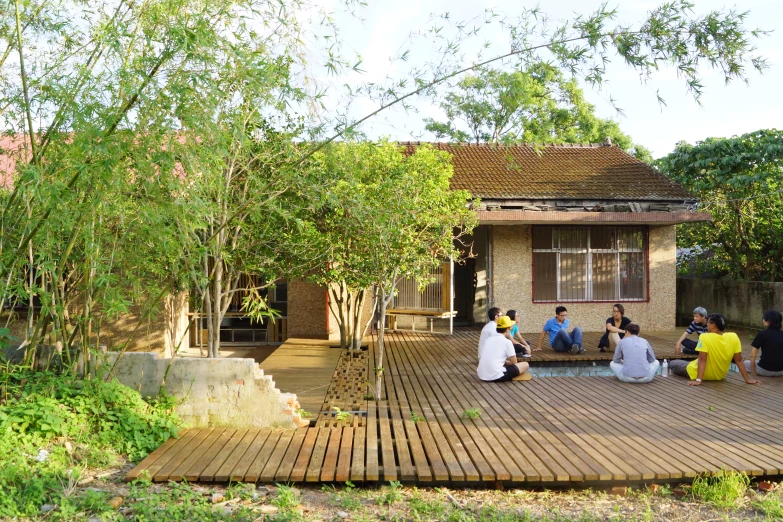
[{"left": 656, "top": 129, "right": 783, "bottom": 281}]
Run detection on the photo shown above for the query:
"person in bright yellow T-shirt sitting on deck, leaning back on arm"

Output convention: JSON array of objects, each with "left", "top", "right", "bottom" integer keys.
[{"left": 669, "top": 314, "right": 761, "bottom": 386}]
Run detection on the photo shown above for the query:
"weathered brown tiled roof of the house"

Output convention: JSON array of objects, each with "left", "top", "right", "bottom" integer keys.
[{"left": 400, "top": 142, "right": 696, "bottom": 201}]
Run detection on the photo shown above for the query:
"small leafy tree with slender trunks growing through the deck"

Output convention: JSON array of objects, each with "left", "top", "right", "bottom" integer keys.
[{"left": 284, "top": 141, "right": 476, "bottom": 397}]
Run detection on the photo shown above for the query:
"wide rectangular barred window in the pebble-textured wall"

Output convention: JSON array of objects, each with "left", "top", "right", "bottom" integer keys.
[{"left": 533, "top": 226, "right": 647, "bottom": 302}]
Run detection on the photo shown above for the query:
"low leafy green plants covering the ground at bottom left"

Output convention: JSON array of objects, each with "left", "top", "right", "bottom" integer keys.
[{"left": 0, "top": 368, "right": 180, "bottom": 518}]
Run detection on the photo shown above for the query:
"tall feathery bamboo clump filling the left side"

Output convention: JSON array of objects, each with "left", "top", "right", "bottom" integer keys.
[{"left": 0, "top": 0, "right": 312, "bottom": 362}]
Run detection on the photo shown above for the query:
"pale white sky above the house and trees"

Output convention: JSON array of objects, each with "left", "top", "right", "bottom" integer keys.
[{"left": 312, "top": 0, "right": 783, "bottom": 158}]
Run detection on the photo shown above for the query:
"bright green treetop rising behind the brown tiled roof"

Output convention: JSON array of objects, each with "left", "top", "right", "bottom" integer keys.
[{"left": 424, "top": 62, "right": 649, "bottom": 159}]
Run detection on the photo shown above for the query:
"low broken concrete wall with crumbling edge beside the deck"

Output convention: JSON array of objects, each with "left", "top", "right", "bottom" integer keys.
[{"left": 108, "top": 352, "right": 296, "bottom": 428}]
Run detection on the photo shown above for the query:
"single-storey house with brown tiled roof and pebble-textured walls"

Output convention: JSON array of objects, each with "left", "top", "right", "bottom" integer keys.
[{"left": 287, "top": 142, "right": 711, "bottom": 338}]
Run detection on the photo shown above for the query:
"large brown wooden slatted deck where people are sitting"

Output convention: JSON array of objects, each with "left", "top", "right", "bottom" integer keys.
[{"left": 127, "top": 330, "right": 783, "bottom": 486}]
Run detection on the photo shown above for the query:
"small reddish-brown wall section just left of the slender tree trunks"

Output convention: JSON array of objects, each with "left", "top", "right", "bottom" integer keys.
[{"left": 288, "top": 279, "right": 333, "bottom": 339}]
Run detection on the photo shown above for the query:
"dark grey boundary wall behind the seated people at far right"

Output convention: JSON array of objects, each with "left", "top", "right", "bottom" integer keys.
[{"left": 677, "top": 278, "right": 783, "bottom": 328}]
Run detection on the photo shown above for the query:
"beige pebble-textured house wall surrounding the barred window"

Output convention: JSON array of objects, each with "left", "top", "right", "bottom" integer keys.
[{"left": 491, "top": 225, "right": 677, "bottom": 332}]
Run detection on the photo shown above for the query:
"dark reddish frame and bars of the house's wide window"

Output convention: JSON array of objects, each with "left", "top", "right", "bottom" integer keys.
[{"left": 530, "top": 224, "right": 650, "bottom": 304}]
